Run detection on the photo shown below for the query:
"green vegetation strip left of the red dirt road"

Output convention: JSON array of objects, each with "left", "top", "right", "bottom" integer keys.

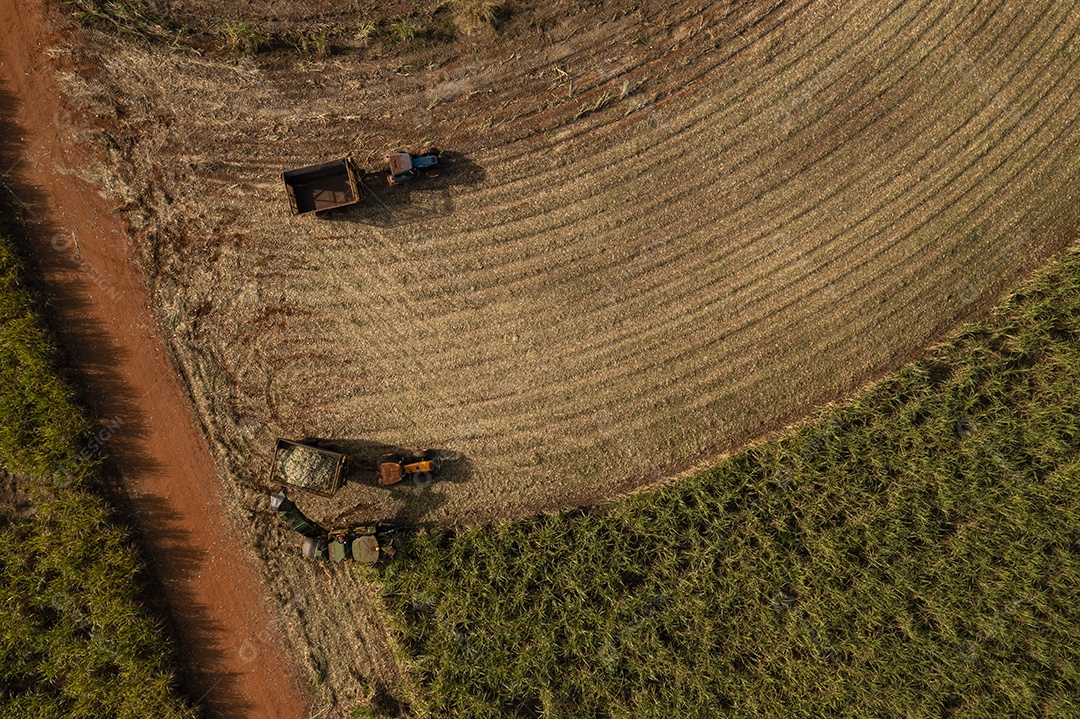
[{"left": 0, "top": 238, "right": 195, "bottom": 719}]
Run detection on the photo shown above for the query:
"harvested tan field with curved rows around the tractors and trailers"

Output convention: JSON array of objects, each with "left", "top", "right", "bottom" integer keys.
[{"left": 69, "top": 0, "right": 1080, "bottom": 524}]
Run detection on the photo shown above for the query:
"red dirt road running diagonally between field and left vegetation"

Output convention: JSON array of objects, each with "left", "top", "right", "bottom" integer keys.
[{"left": 0, "top": 0, "right": 311, "bottom": 719}]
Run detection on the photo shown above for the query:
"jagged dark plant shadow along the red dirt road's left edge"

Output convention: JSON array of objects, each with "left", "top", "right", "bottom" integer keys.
[{"left": 0, "top": 80, "right": 253, "bottom": 717}]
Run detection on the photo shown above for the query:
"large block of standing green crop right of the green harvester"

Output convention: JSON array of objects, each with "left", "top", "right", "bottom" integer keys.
[{"left": 382, "top": 243, "right": 1080, "bottom": 719}]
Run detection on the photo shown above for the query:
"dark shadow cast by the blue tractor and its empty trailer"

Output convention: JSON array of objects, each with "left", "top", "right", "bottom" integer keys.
[{"left": 325, "top": 151, "right": 487, "bottom": 229}]
